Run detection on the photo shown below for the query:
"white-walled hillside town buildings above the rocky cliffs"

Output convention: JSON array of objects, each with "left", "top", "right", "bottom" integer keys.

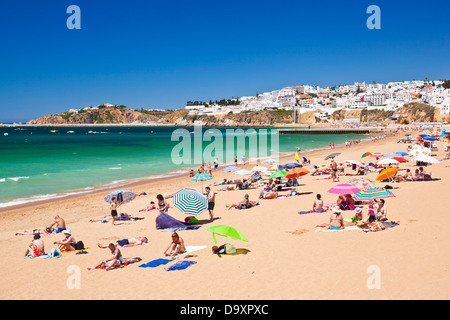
[{"left": 185, "top": 80, "right": 450, "bottom": 121}]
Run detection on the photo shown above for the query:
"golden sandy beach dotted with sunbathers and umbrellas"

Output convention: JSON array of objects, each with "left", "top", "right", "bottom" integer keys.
[{"left": 0, "top": 128, "right": 450, "bottom": 300}]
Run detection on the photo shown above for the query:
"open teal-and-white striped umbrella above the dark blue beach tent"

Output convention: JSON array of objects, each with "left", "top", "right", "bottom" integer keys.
[{"left": 173, "top": 189, "right": 208, "bottom": 215}]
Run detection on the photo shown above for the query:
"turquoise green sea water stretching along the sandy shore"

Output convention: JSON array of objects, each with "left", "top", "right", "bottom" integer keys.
[{"left": 0, "top": 126, "right": 364, "bottom": 208}]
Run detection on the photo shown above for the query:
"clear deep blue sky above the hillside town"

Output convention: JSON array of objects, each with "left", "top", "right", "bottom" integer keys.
[{"left": 0, "top": 0, "right": 450, "bottom": 122}]
